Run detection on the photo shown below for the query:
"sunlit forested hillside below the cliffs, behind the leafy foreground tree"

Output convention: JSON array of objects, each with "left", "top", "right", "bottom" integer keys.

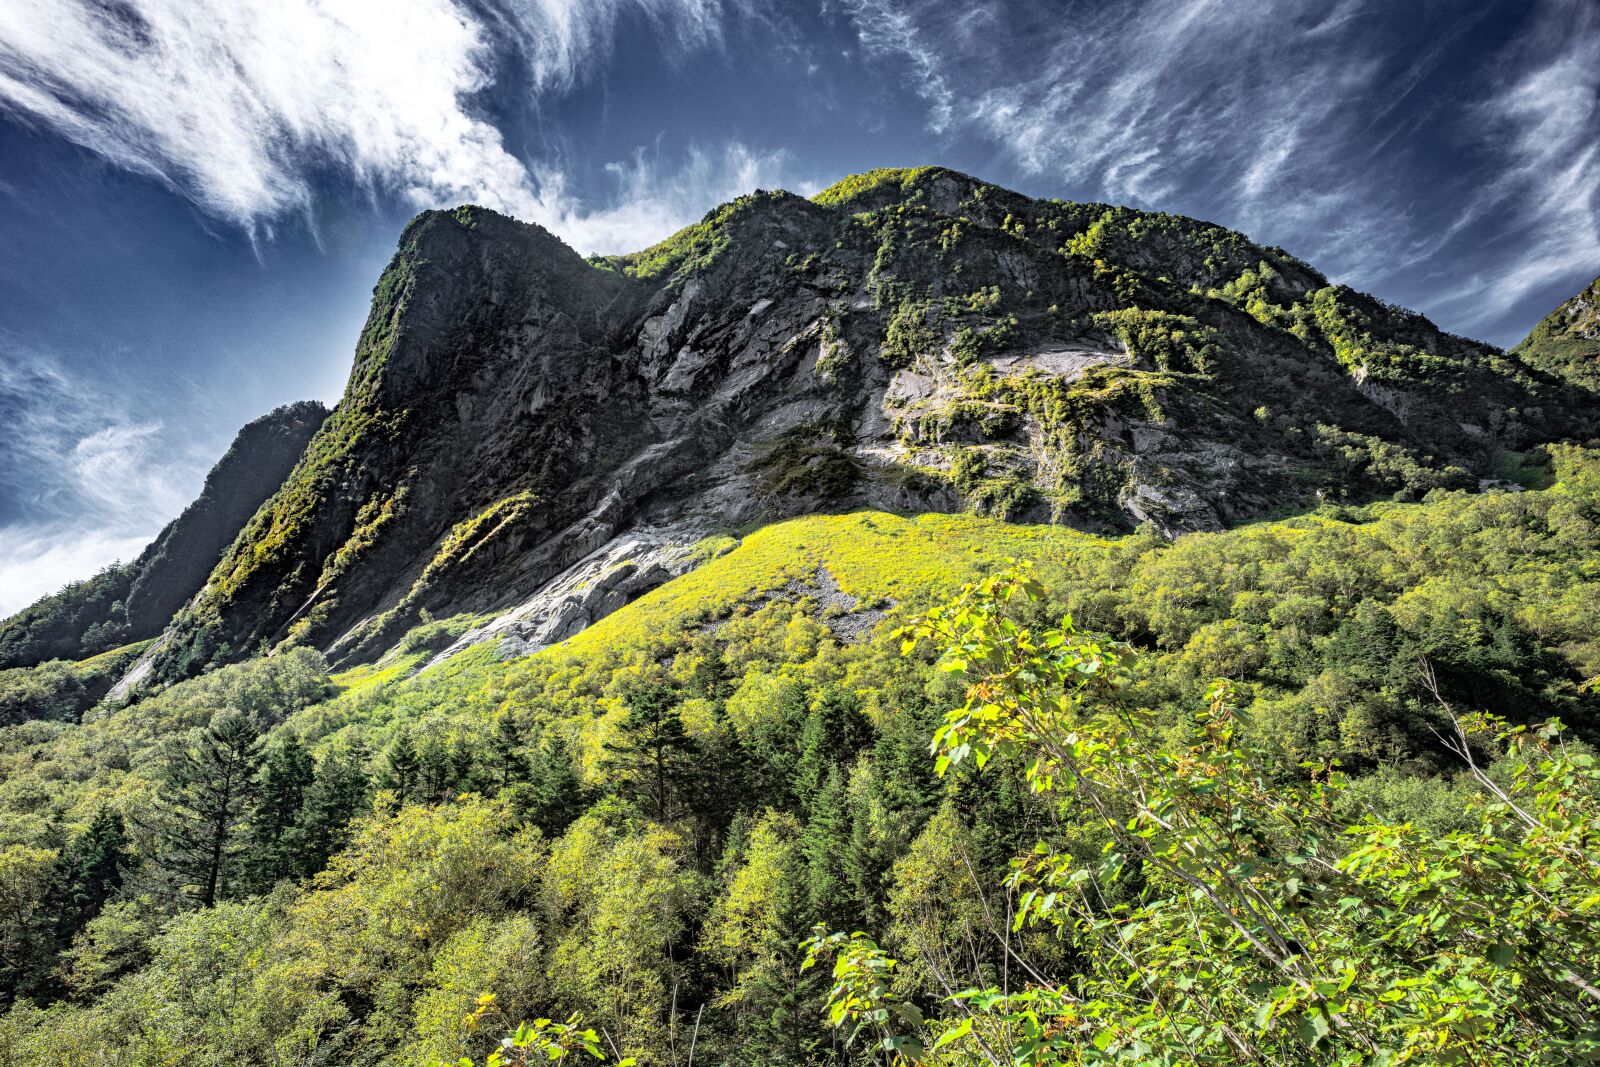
[{"left": 0, "top": 450, "right": 1600, "bottom": 1064}]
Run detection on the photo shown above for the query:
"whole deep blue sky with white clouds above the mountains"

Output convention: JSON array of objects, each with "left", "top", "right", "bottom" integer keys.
[{"left": 0, "top": 0, "right": 1600, "bottom": 614}]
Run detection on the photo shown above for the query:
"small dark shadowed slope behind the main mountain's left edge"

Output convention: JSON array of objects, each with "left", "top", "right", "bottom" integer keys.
[{"left": 0, "top": 402, "right": 328, "bottom": 667}]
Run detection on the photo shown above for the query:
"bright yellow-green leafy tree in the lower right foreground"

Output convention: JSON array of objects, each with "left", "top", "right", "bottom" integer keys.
[{"left": 811, "top": 573, "right": 1600, "bottom": 1067}]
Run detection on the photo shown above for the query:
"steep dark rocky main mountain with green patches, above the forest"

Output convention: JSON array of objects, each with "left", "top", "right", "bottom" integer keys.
[{"left": 134, "top": 168, "right": 1592, "bottom": 678}]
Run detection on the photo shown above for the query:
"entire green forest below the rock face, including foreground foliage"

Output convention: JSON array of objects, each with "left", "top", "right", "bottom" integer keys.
[{"left": 0, "top": 446, "right": 1600, "bottom": 1065}]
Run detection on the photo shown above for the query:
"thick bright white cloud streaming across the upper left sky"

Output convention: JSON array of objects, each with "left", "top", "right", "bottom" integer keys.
[{"left": 0, "top": 0, "right": 779, "bottom": 251}]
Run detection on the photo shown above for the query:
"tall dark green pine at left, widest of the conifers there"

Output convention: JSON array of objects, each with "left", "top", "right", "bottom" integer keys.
[{"left": 152, "top": 710, "right": 261, "bottom": 907}]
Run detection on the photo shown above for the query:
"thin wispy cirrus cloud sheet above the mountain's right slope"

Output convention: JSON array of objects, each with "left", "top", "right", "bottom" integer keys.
[{"left": 843, "top": 0, "right": 1600, "bottom": 342}]
